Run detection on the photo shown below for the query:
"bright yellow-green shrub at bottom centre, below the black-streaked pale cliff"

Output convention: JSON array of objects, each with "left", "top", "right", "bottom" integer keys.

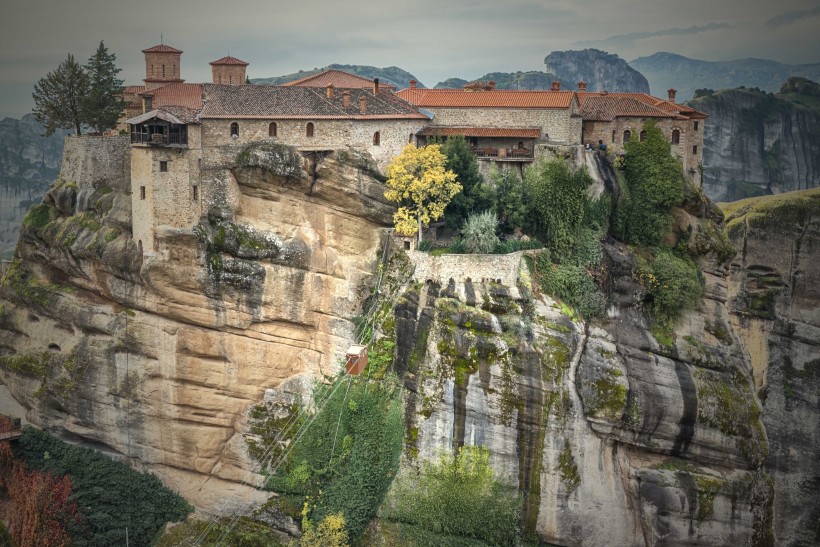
[{"left": 382, "top": 446, "right": 521, "bottom": 545}]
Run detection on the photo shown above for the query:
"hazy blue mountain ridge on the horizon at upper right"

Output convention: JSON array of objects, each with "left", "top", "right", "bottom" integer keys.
[{"left": 629, "top": 52, "right": 820, "bottom": 100}]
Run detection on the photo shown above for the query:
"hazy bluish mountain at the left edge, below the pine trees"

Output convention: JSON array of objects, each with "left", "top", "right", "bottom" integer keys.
[{"left": 0, "top": 114, "right": 68, "bottom": 257}]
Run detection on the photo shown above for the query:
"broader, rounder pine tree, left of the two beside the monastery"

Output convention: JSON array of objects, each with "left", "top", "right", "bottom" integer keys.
[{"left": 32, "top": 53, "right": 89, "bottom": 137}]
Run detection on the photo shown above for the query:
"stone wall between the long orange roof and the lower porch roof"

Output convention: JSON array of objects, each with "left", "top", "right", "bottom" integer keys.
[{"left": 427, "top": 108, "right": 581, "bottom": 144}]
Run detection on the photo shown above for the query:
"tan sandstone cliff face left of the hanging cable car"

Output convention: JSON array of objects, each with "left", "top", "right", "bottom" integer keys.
[{"left": 0, "top": 138, "right": 392, "bottom": 510}]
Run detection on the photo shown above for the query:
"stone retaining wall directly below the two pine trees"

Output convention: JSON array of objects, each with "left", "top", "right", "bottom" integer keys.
[{"left": 60, "top": 135, "right": 131, "bottom": 190}]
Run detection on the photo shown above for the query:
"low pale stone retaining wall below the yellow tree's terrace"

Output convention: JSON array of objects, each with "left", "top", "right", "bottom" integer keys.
[{"left": 409, "top": 251, "right": 523, "bottom": 287}]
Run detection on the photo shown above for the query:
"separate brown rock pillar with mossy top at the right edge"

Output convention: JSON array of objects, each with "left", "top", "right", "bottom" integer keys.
[{"left": 726, "top": 189, "right": 820, "bottom": 545}]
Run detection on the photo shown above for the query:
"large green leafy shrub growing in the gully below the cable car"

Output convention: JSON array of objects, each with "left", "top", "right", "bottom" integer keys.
[{"left": 268, "top": 374, "right": 404, "bottom": 540}]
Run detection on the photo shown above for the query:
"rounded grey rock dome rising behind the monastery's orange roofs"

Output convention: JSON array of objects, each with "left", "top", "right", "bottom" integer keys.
[{"left": 544, "top": 49, "right": 649, "bottom": 93}]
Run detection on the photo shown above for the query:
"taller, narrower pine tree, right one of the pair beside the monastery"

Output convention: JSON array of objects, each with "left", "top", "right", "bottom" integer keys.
[{"left": 82, "top": 41, "right": 125, "bottom": 133}]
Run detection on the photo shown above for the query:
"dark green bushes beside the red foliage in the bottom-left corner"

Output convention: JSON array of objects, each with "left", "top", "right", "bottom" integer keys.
[{"left": 14, "top": 427, "right": 193, "bottom": 546}]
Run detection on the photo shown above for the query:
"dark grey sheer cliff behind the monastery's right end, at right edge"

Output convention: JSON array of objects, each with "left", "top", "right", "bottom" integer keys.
[{"left": 689, "top": 83, "right": 820, "bottom": 206}]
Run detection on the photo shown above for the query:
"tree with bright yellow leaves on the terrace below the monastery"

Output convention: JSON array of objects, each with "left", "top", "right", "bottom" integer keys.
[{"left": 384, "top": 144, "right": 461, "bottom": 243}]
